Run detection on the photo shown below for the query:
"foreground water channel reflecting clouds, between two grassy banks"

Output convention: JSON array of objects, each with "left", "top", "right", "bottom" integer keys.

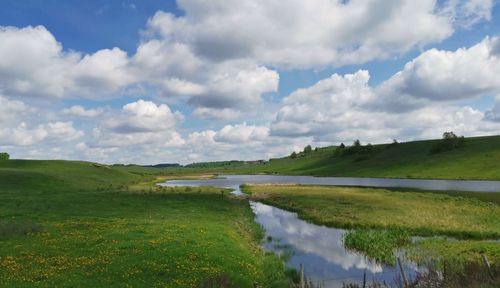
[{"left": 250, "top": 202, "right": 416, "bottom": 287}]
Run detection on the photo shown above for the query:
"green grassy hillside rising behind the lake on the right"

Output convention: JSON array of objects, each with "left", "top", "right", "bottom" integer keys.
[{"left": 234, "top": 136, "right": 500, "bottom": 180}]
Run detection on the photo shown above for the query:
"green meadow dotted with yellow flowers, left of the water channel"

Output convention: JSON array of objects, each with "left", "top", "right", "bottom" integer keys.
[{"left": 0, "top": 160, "right": 286, "bottom": 287}]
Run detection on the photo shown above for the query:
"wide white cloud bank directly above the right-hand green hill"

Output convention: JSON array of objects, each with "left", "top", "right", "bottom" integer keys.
[{"left": 270, "top": 63, "right": 500, "bottom": 143}]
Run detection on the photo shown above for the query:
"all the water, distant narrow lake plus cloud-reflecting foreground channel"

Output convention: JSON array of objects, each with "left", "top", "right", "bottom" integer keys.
[{"left": 159, "top": 175, "right": 500, "bottom": 287}]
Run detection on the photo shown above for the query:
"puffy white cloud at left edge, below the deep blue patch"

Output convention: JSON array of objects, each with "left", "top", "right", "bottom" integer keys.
[{"left": 0, "top": 26, "right": 131, "bottom": 98}]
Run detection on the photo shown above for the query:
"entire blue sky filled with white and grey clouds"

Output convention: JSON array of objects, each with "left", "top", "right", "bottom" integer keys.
[{"left": 0, "top": 0, "right": 500, "bottom": 164}]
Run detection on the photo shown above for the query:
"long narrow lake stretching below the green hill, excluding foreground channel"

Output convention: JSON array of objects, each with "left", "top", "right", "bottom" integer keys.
[{"left": 160, "top": 175, "right": 500, "bottom": 192}]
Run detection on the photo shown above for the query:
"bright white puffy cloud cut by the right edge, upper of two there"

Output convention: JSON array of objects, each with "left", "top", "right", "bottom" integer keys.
[{"left": 380, "top": 38, "right": 500, "bottom": 100}]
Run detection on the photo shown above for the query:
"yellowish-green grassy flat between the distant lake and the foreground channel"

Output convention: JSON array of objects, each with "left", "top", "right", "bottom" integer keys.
[{"left": 243, "top": 185, "right": 500, "bottom": 263}]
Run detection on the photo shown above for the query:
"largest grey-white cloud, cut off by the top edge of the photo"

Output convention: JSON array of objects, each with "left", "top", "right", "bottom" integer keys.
[{"left": 148, "top": 0, "right": 458, "bottom": 68}]
